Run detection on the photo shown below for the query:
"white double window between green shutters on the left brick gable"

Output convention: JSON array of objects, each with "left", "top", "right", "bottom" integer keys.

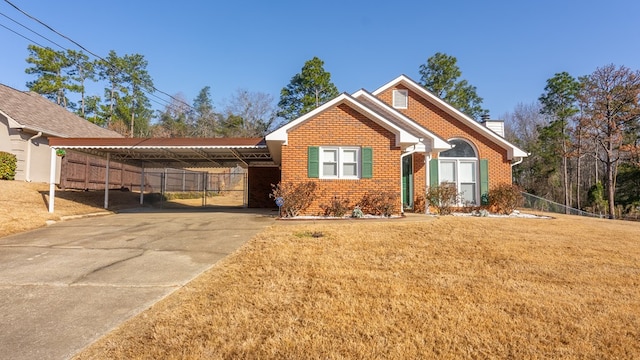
[{"left": 320, "top": 147, "right": 360, "bottom": 179}]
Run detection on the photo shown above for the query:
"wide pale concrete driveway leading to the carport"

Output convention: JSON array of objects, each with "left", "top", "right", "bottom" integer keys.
[{"left": 0, "top": 210, "right": 274, "bottom": 360}]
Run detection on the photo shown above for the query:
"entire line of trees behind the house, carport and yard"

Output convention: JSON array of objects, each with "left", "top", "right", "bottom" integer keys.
[{"left": 26, "top": 45, "right": 640, "bottom": 218}]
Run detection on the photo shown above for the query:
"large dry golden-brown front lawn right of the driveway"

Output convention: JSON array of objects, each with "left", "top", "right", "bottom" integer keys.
[{"left": 72, "top": 216, "right": 640, "bottom": 359}]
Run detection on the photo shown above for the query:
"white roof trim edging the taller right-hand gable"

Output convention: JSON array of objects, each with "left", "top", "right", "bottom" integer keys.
[{"left": 373, "top": 75, "right": 529, "bottom": 159}]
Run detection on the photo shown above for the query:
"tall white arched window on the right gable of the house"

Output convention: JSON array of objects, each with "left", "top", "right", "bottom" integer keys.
[{"left": 438, "top": 139, "right": 479, "bottom": 205}]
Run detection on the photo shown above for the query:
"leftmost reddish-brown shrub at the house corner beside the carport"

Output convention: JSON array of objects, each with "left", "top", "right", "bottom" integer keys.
[{"left": 269, "top": 181, "right": 316, "bottom": 217}]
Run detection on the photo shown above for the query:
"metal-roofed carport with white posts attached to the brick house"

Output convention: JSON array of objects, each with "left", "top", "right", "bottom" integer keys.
[{"left": 49, "top": 138, "right": 275, "bottom": 213}]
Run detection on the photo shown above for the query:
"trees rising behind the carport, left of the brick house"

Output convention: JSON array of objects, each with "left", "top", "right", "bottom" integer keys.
[{"left": 25, "top": 45, "right": 276, "bottom": 137}]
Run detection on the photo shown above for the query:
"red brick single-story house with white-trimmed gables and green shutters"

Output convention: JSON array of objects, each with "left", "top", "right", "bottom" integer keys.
[{"left": 262, "top": 75, "right": 527, "bottom": 214}]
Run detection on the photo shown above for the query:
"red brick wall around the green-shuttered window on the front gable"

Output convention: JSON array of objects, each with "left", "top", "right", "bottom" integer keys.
[{"left": 282, "top": 104, "right": 401, "bottom": 215}]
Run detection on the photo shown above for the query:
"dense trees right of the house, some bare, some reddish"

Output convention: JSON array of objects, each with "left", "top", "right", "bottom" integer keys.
[{"left": 505, "top": 64, "right": 640, "bottom": 218}]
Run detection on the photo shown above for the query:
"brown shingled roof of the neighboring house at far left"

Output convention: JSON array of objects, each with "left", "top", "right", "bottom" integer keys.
[{"left": 0, "top": 84, "right": 122, "bottom": 138}]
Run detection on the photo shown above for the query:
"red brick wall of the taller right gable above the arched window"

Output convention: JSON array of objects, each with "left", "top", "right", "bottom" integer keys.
[{"left": 378, "top": 85, "right": 512, "bottom": 187}]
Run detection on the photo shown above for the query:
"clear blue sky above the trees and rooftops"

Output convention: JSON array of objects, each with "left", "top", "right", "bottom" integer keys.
[{"left": 0, "top": 0, "right": 640, "bottom": 118}]
